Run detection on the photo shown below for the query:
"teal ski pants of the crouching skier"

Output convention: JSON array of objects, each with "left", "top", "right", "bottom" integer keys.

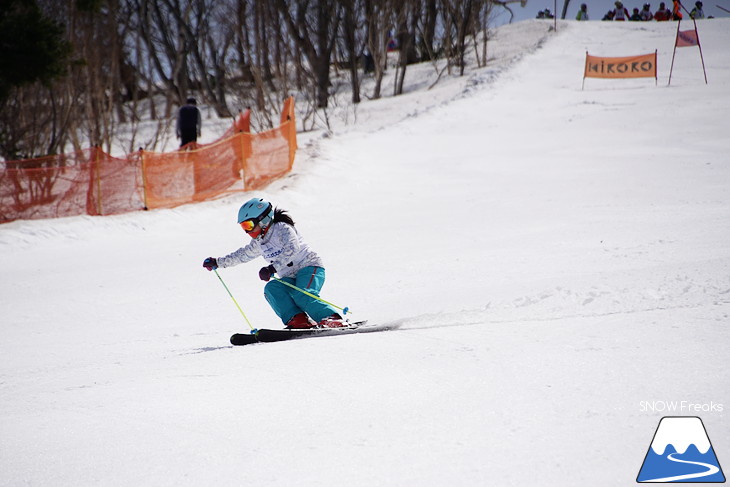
[{"left": 264, "top": 267, "right": 337, "bottom": 325}]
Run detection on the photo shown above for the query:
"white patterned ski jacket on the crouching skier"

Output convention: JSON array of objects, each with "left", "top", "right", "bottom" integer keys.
[{"left": 216, "top": 222, "right": 324, "bottom": 277}]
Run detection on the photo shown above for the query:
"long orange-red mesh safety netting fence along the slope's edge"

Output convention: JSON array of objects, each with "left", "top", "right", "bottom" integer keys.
[{"left": 0, "top": 98, "right": 296, "bottom": 223}]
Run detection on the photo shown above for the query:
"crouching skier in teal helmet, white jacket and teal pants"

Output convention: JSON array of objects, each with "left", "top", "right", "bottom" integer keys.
[{"left": 203, "top": 198, "right": 348, "bottom": 329}]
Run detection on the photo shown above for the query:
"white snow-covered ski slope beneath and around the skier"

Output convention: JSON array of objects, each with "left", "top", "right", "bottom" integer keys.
[{"left": 0, "top": 20, "right": 730, "bottom": 487}]
